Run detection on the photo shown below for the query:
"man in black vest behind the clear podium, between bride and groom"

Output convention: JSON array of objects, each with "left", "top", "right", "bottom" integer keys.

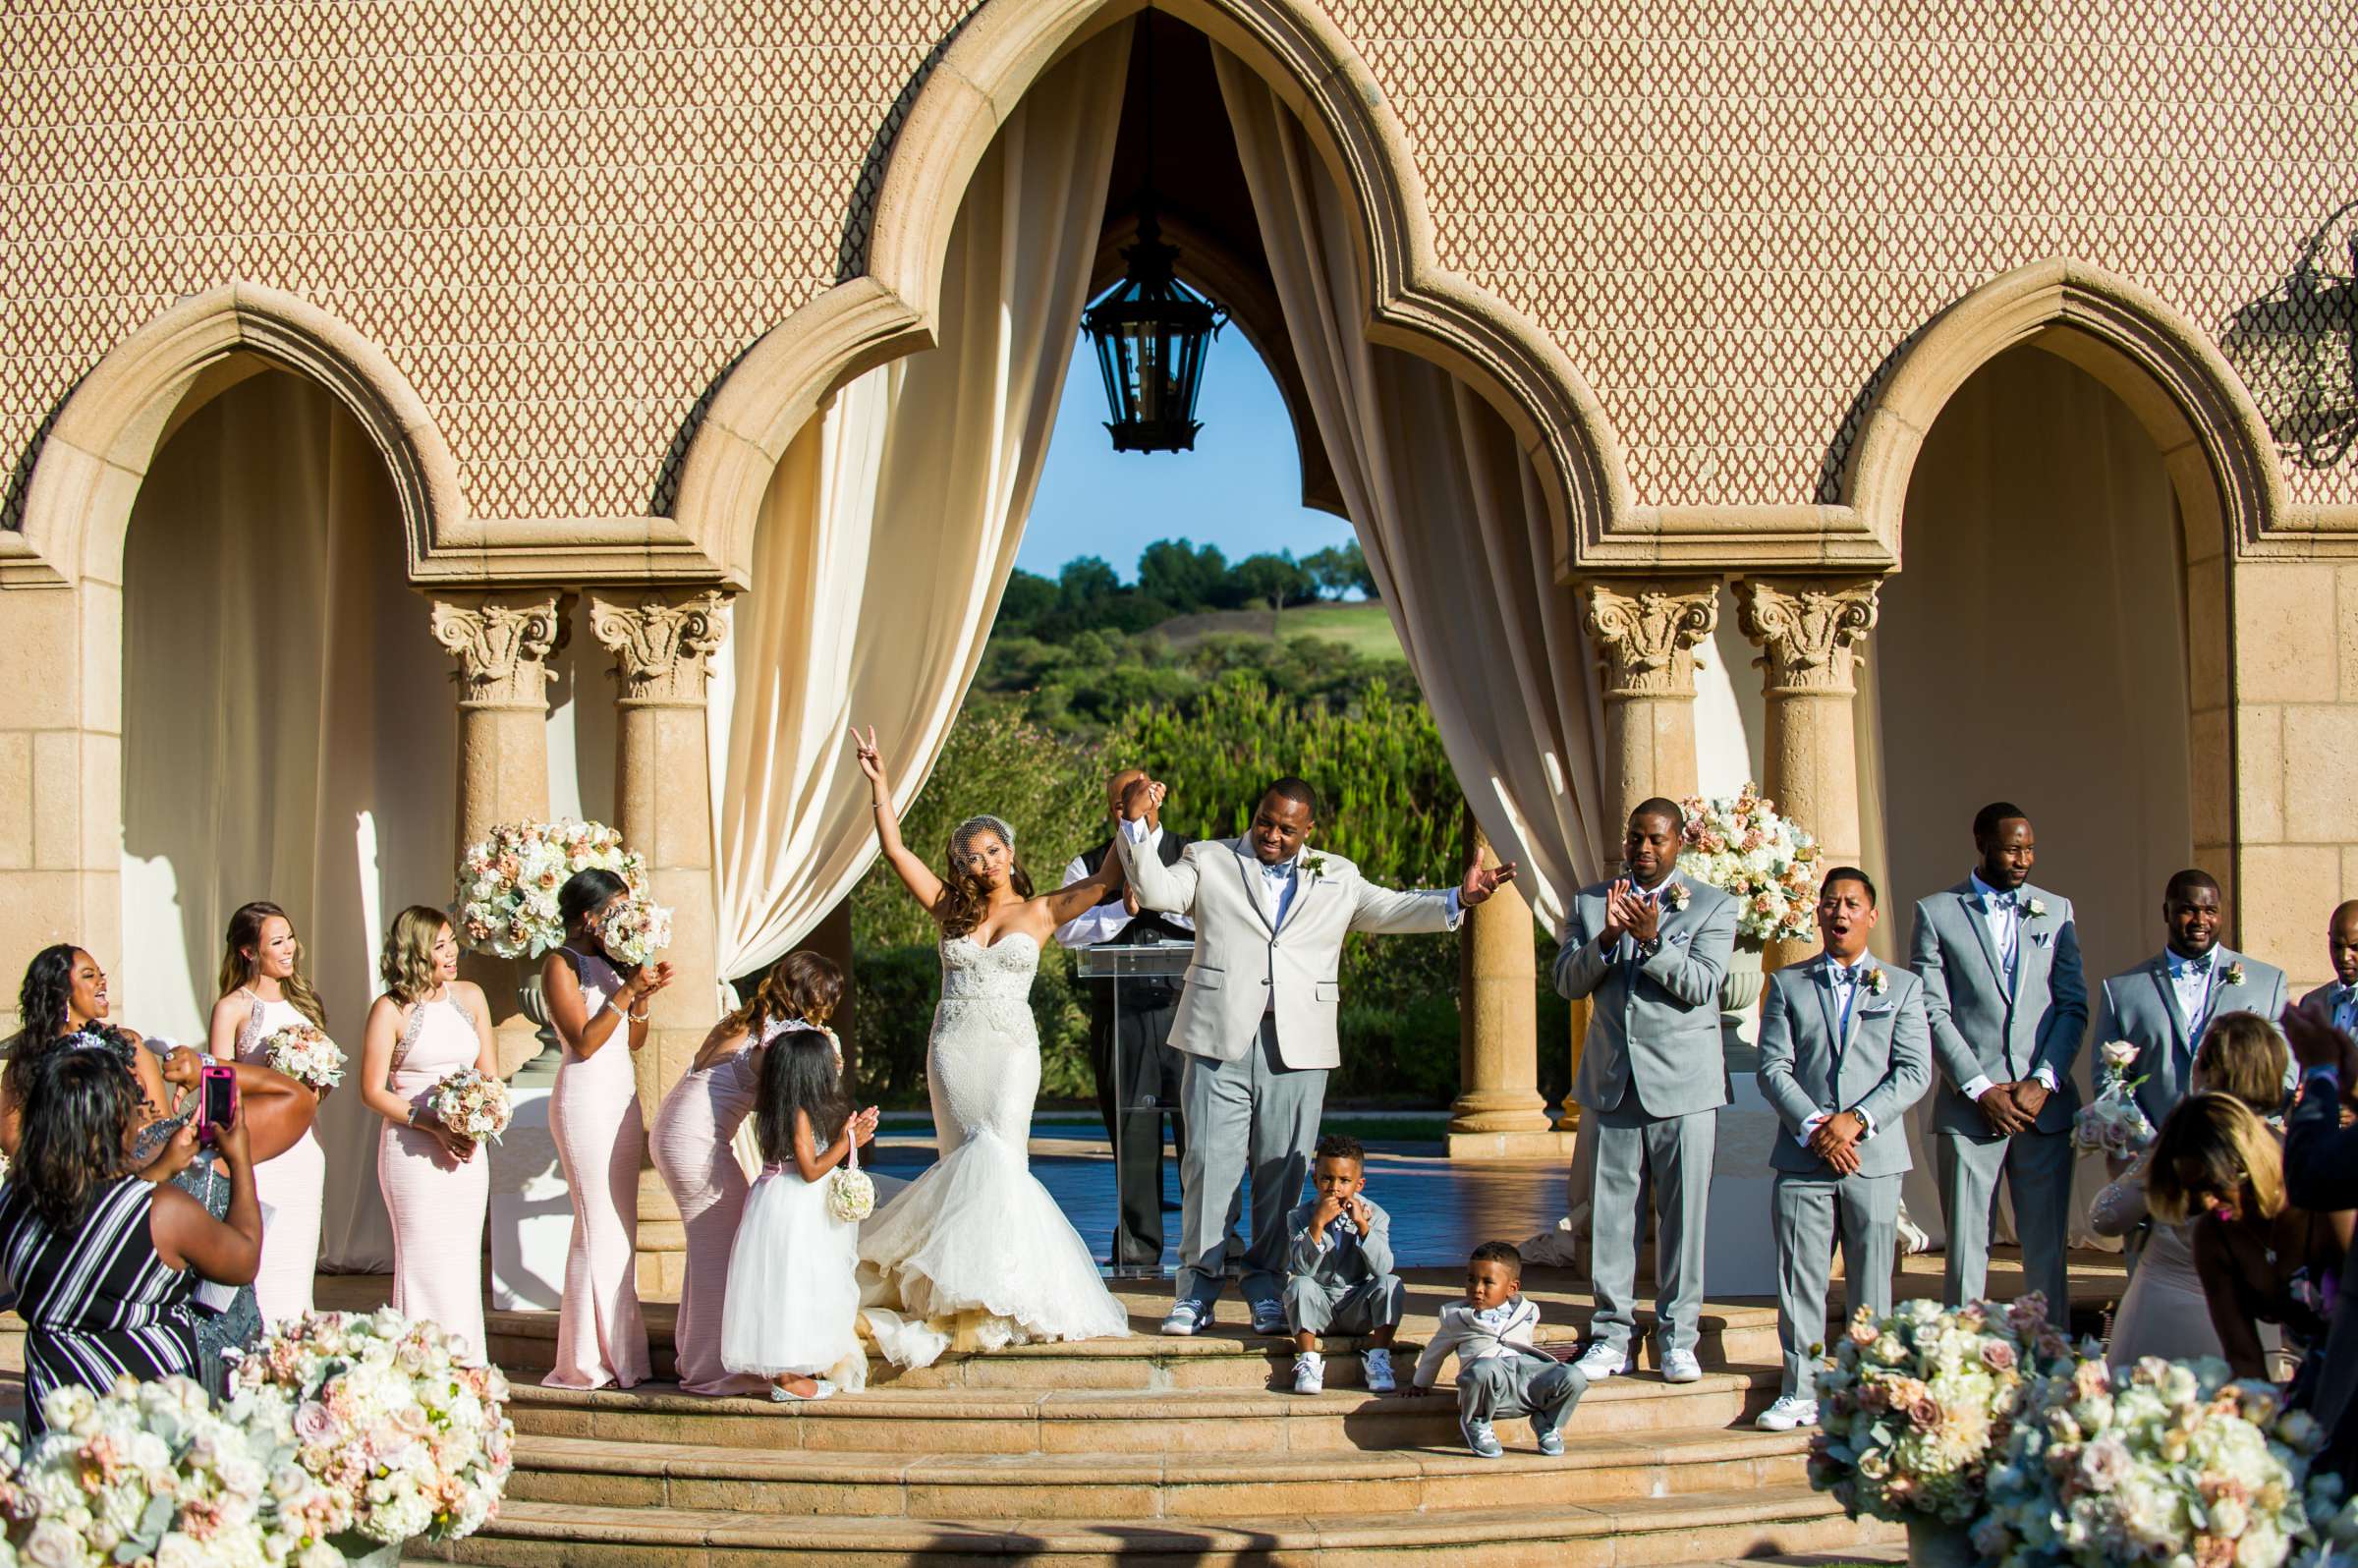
[{"left": 1056, "top": 768, "right": 1196, "bottom": 1268}]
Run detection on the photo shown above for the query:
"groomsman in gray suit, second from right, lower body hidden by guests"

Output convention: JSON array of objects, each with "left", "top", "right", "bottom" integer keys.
[{"left": 2097, "top": 870, "right": 2282, "bottom": 1127}]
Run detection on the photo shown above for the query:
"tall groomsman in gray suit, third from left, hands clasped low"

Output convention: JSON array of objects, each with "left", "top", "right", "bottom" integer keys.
[{"left": 1910, "top": 802, "right": 2087, "bottom": 1322}]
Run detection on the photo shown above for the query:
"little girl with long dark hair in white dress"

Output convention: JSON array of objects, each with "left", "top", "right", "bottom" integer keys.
[{"left": 721, "top": 1028, "right": 877, "bottom": 1398}]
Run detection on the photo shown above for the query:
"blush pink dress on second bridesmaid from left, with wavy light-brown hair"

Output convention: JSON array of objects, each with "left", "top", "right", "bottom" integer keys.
[{"left": 377, "top": 997, "right": 490, "bottom": 1358}]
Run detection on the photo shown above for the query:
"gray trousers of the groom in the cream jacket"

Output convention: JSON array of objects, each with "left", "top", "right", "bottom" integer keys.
[{"left": 1177, "top": 1014, "right": 1327, "bottom": 1302}]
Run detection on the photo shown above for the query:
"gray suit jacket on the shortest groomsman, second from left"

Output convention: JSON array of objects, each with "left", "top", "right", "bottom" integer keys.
[{"left": 1759, "top": 953, "right": 1932, "bottom": 1177}]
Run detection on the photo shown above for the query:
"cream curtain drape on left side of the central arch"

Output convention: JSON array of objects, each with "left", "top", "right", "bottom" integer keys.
[{"left": 712, "top": 22, "right": 1132, "bottom": 977}]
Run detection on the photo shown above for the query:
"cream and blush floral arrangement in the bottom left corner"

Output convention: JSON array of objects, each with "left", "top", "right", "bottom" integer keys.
[{"left": 0, "top": 1377, "right": 283, "bottom": 1568}]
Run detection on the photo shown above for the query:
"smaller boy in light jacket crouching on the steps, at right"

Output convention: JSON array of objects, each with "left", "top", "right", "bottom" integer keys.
[{"left": 1410, "top": 1240, "right": 1590, "bottom": 1460}]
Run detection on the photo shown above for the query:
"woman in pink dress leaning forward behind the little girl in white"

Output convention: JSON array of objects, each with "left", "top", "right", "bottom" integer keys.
[{"left": 650, "top": 953, "right": 844, "bottom": 1393}]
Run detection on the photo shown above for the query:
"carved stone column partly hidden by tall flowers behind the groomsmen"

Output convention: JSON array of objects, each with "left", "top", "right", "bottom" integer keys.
[{"left": 1556, "top": 578, "right": 1719, "bottom": 1130}]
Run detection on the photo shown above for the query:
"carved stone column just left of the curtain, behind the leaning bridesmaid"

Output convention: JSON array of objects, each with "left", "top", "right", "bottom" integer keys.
[{"left": 590, "top": 588, "right": 729, "bottom": 1297}]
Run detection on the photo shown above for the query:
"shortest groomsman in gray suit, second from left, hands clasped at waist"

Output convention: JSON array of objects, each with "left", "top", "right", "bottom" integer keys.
[{"left": 1759, "top": 866, "right": 1932, "bottom": 1431}]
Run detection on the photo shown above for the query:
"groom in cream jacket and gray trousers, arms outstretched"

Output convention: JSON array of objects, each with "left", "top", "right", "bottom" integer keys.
[{"left": 1113, "top": 778, "right": 1514, "bottom": 1334}]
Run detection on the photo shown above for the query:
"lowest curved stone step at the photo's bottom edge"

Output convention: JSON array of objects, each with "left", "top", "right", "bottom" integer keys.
[{"left": 434, "top": 1489, "right": 1896, "bottom": 1568}]
